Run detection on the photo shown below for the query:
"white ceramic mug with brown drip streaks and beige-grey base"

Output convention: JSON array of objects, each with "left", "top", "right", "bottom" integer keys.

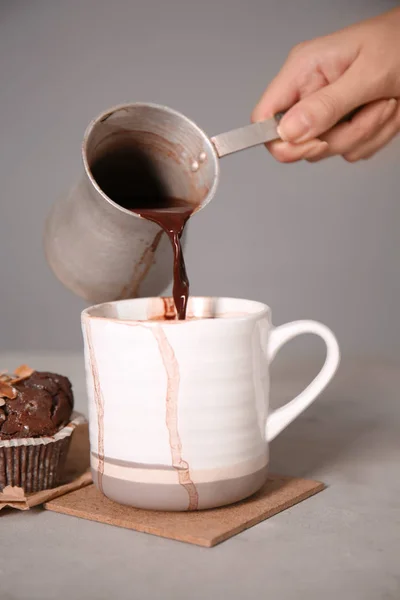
[{"left": 82, "top": 297, "right": 340, "bottom": 511}]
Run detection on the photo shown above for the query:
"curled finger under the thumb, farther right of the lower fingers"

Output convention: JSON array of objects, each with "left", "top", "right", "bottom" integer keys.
[{"left": 307, "top": 98, "right": 397, "bottom": 162}]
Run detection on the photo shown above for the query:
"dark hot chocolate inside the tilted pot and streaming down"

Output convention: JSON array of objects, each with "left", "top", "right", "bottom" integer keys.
[{"left": 92, "top": 147, "right": 195, "bottom": 319}]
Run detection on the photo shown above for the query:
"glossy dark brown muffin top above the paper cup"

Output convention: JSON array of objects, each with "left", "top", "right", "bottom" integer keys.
[{"left": 0, "top": 371, "right": 74, "bottom": 440}]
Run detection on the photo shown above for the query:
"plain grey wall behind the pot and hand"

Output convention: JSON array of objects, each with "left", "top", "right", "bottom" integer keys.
[{"left": 0, "top": 0, "right": 400, "bottom": 360}]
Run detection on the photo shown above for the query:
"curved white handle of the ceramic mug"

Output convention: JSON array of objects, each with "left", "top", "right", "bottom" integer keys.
[{"left": 266, "top": 321, "right": 340, "bottom": 442}]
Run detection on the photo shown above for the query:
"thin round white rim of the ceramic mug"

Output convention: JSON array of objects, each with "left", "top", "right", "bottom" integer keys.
[{"left": 81, "top": 296, "right": 271, "bottom": 327}]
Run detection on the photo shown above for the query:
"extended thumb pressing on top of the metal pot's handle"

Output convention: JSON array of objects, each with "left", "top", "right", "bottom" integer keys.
[{"left": 279, "top": 63, "right": 368, "bottom": 143}]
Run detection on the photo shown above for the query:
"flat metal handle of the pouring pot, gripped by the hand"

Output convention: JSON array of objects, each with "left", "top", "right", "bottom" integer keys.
[{"left": 211, "top": 107, "right": 362, "bottom": 158}]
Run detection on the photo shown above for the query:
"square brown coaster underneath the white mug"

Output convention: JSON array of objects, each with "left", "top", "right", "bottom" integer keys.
[{"left": 45, "top": 475, "right": 325, "bottom": 548}]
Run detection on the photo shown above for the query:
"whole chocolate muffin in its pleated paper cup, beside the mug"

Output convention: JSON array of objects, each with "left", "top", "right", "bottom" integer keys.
[{"left": 0, "top": 365, "right": 74, "bottom": 492}]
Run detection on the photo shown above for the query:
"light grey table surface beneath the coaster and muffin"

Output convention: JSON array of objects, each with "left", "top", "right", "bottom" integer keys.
[{"left": 0, "top": 354, "right": 400, "bottom": 600}]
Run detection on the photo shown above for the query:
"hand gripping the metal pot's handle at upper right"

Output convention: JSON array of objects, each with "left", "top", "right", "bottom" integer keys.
[{"left": 252, "top": 8, "right": 400, "bottom": 162}]
